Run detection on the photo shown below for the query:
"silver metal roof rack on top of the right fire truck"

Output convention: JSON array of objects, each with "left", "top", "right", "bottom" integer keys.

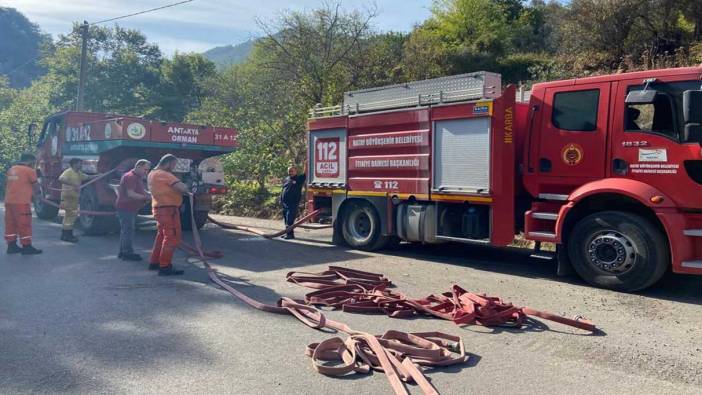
[{"left": 310, "top": 71, "right": 502, "bottom": 118}]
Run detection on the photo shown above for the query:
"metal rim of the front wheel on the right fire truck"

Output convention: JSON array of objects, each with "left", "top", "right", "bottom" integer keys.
[{"left": 587, "top": 230, "right": 639, "bottom": 275}]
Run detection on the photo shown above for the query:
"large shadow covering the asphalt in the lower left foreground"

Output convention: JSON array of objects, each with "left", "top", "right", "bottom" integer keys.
[{"left": 0, "top": 213, "right": 294, "bottom": 393}]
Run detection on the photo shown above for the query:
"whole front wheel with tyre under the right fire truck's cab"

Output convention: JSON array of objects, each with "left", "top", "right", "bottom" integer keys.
[{"left": 568, "top": 211, "right": 670, "bottom": 292}]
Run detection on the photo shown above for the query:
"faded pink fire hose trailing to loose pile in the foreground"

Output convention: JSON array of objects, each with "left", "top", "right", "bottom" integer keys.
[{"left": 181, "top": 195, "right": 470, "bottom": 395}]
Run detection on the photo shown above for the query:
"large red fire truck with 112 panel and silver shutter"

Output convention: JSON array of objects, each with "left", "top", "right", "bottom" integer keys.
[{"left": 308, "top": 67, "right": 702, "bottom": 291}]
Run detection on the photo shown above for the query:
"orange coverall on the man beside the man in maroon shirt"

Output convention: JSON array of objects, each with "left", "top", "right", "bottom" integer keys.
[{"left": 148, "top": 170, "right": 183, "bottom": 268}]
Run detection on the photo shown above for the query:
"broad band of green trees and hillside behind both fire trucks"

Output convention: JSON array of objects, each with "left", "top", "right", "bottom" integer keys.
[{"left": 0, "top": 0, "right": 702, "bottom": 215}]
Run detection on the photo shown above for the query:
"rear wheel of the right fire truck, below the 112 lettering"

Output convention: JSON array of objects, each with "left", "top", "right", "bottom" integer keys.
[{"left": 341, "top": 202, "right": 388, "bottom": 251}]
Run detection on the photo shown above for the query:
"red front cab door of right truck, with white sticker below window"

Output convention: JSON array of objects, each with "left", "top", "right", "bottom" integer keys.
[{"left": 608, "top": 74, "right": 702, "bottom": 208}]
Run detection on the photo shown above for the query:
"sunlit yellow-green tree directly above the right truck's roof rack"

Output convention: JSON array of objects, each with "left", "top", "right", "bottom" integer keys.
[{"left": 404, "top": 0, "right": 551, "bottom": 82}]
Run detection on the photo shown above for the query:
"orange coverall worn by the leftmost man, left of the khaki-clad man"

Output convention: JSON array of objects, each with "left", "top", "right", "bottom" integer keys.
[{"left": 5, "top": 164, "right": 37, "bottom": 246}]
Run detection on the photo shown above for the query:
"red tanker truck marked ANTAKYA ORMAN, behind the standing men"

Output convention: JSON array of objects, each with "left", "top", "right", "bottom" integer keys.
[{"left": 30, "top": 112, "right": 237, "bottom": 234}]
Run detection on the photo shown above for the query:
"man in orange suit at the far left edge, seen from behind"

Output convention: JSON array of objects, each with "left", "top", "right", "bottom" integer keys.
[{"left": 5, "top": 154, "right": 41, "bottom": 255}]
